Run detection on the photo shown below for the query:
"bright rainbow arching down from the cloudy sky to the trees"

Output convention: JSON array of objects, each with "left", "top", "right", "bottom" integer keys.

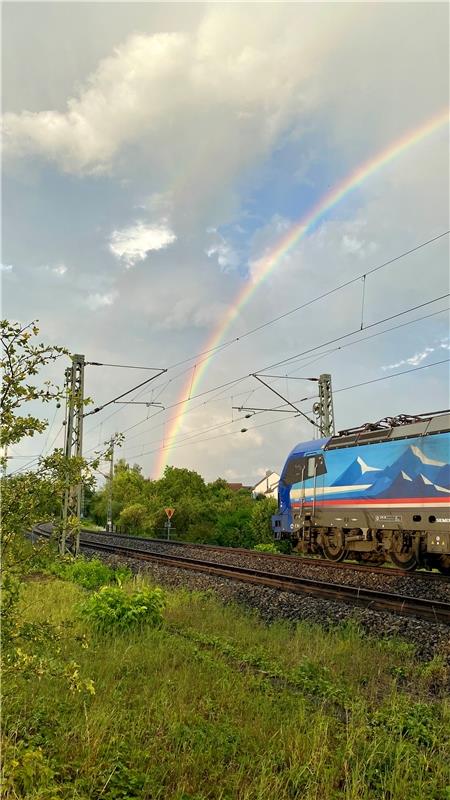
[{"left": 155, "top": 109, "right": 449, "bottom": 476}]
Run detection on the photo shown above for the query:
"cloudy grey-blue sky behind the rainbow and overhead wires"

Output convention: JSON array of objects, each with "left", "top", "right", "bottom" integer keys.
[{"left": 1, "top": 2, "right": 450, "bottom": 485}]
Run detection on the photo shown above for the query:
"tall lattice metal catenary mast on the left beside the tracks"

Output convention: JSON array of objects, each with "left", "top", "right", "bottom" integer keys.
[{"left": 59, "top": 354, "right": 84, "bottom": 556}]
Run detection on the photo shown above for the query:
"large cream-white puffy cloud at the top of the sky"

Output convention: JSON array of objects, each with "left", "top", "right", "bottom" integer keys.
[{"left": 0, "top": 6, "right": 346, "bottom": 177}]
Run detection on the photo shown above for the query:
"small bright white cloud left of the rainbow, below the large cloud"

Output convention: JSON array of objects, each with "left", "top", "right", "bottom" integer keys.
[{"left": 109, "top": 222, "right": 177, "bottom": 269}]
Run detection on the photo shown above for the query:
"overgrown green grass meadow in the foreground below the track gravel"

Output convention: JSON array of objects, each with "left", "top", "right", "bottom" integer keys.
[{"left": 3, "top": 578, "right": 450, "bottom": 800}]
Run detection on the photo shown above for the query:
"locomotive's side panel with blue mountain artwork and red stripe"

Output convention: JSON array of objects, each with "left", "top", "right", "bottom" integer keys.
[{"left": 296, "top": 433, "right": 450, "bottom": 534}]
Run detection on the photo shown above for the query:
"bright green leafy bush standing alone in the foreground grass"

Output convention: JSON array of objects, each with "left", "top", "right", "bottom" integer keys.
[{"left": 80, "top": 586, "right": 165, "bottom": 633}]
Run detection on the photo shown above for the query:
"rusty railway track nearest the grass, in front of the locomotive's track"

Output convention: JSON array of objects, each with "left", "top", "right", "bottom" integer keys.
[{"left": 31, "top": 527, "right": 450, "bottom": 624}]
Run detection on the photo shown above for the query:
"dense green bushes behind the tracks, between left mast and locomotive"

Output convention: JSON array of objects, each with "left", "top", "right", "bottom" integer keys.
[{"left": 86, "top": 460, "right": 279, "bottom": 552}]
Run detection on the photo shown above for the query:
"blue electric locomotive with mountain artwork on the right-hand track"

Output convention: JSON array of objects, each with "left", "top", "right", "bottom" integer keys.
[{"left": 272, "top": 411, "right": 450, "bottom": 574}]
